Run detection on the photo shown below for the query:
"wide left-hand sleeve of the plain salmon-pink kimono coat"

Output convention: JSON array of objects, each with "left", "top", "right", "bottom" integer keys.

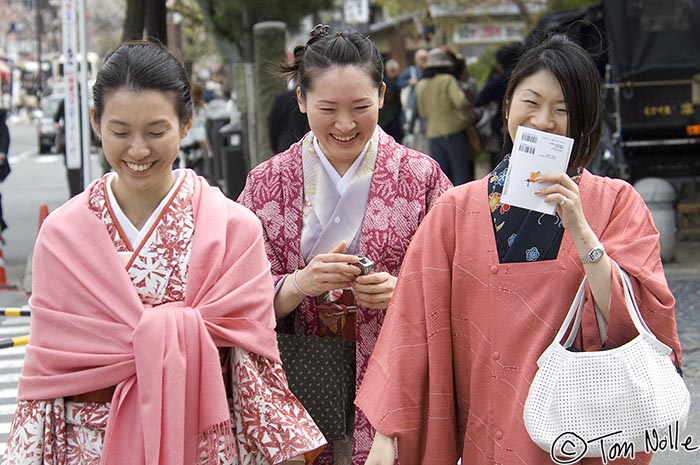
[{"left": 355, "top": 202, "right": 460, "bottom": 465}]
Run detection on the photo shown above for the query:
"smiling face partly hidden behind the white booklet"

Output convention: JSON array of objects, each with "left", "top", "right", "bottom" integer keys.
[{"left": 506, "top": 69, "right": 569, "bottom": 140}]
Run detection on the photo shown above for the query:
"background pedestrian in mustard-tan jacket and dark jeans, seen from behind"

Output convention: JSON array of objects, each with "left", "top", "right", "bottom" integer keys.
[{"left": 416, "top": 48, "right": 473, "bottom": 186}]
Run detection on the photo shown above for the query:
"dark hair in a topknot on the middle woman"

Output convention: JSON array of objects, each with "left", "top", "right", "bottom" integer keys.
[{"left": 280, "top": 24, "right": 384, "bottom": 98}]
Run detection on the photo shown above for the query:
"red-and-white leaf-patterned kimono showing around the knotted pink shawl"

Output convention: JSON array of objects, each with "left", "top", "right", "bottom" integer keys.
[{"left": 3, "top": 172, "right": 325, "bottom": 465}]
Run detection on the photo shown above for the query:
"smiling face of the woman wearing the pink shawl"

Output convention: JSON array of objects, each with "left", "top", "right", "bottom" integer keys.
[{"left": 91, "top": 88, "right": 192, "bottom": 199}]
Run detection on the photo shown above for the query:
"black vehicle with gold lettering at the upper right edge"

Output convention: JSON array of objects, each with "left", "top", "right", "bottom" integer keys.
[{"left": 537, "top": 0, "right": 700, "bottom": 182}]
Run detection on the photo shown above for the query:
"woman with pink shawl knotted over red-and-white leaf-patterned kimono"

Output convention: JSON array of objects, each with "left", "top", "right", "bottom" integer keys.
[{"left": 4, "top": 42, "right": 325, "bottom": 465}]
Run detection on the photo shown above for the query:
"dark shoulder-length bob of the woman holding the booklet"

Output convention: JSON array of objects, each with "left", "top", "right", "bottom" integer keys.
[{"left": 503, "top": 34, "right": 602, "bottom": 175}]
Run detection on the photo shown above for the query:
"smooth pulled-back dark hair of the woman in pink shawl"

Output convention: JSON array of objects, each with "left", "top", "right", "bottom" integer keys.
[{"left": 92, "top": 40, "right": 194, "bottom": 124}]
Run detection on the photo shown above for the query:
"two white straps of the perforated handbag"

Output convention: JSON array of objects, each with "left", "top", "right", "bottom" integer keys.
[{"left": 537, "top": 261, "right": 670, "bottom": 366}]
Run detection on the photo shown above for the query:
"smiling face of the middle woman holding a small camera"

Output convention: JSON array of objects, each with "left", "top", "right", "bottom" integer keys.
[{"left": 297, "top": 66, "right": 385, "bottom": 174}]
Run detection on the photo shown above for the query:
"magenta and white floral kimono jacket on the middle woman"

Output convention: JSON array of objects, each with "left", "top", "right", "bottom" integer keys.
[{"left": 238, "top": 127, "right": 451, "bottom": 465}]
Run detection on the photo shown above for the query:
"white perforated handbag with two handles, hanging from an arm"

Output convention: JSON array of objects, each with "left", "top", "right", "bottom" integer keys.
[{"left": 523, "top": 265, "right": 690, "bottom": 463}]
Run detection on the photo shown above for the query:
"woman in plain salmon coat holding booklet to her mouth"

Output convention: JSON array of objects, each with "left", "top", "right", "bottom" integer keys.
[{"left": 356, "top": 36, "right": 681, "bottom": 465}]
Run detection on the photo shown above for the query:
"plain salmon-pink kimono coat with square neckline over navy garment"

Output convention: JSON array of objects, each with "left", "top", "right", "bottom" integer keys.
[{"left": 356, "top": 171, "right": 681, "bottom": 465}]
